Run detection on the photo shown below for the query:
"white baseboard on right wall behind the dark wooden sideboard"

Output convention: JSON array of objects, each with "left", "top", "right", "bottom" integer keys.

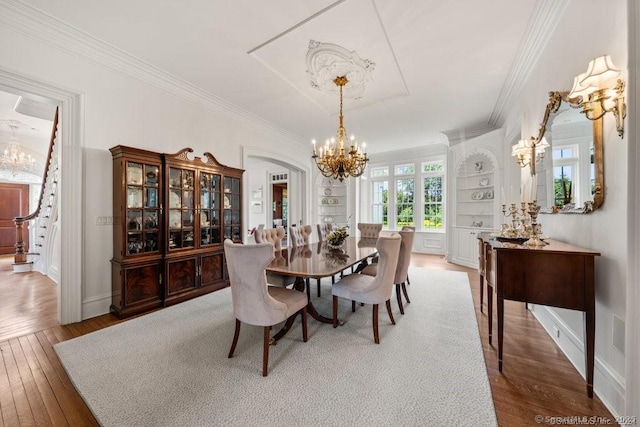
[{"left": 529, "top": 304, "right": 625, "bottom": 417}]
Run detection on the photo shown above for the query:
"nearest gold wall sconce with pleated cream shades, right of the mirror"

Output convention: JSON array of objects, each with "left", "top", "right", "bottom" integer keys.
[{"left": 569, "top": 55, "right": 627, "bottom": 138}]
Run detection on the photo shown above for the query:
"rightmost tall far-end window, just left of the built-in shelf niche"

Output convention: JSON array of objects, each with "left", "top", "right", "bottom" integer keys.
[{"left": 422, "top": 160, "right": 444, "bottom": 230}]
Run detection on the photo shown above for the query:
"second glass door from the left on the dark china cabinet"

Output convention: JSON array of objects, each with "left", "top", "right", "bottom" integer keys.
[{"left": 167, "top": 167, "right": 195, "bottom": 250}]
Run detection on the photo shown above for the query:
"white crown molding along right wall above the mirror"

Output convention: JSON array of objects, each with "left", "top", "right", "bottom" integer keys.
[{"left": 489, "top": 0, "right": 569, "bottom": 127}]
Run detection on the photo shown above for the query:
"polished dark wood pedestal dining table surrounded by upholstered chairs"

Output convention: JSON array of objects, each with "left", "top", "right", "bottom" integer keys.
[{"left": 266, "top": 236, "right": 377, "bottom": 342}]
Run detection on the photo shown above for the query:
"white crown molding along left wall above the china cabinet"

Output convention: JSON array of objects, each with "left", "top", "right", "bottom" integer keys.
[{"left": 0, "top": 0, "right": 303, "bottom": 145}]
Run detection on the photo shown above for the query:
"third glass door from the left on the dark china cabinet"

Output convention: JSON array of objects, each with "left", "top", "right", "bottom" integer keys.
[{"left": 200, "top": 172, "right": 222, "bottom": 246}]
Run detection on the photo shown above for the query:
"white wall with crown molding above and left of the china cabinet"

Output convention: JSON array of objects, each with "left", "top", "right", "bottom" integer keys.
[{"left": 0, "top": 5, "right": 309, "bottom": 319}]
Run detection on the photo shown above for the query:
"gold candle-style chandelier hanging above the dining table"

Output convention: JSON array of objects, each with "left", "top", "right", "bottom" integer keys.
[{"left": 311, "top": 76, "right": 369, "bottom": 181}]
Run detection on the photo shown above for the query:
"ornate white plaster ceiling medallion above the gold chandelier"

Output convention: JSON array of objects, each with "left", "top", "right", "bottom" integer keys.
[{"left": 307, "top": 40, "right": 376, "bottom": 99}]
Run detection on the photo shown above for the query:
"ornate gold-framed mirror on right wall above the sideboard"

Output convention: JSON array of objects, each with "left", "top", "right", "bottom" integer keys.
[{"left": 536, "top": 91, "right": 604, "bottom": 214}]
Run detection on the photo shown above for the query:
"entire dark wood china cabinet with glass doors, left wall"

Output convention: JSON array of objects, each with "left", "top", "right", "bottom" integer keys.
[{"left": 111, "top": 146, "right": 243, "bottom": 317}]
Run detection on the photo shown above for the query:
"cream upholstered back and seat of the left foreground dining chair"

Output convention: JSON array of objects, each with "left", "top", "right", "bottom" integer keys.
[{"left": 224, "top": 239, "right": 287, "bottom": 326}]
